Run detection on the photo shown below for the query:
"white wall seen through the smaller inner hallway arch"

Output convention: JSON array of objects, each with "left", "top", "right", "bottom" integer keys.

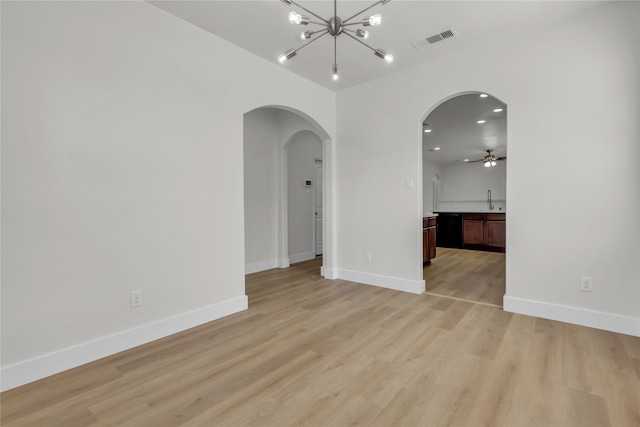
[{"left": 287, "top": 131, "right": 322, "bottom": 263}]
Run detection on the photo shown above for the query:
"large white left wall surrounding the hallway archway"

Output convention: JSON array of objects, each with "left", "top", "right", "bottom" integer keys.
[{"left": 1, "top": 2, "right": 335, "bottom": 389}]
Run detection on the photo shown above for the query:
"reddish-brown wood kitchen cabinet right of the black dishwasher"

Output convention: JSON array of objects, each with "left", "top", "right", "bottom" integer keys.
[{"left": 462, "top": 214, "right": 506, "bottom": 252}]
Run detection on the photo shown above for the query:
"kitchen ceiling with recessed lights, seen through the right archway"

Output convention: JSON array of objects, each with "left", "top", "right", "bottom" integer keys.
[{"left": 422, "top": 93, "right": 507, "bottom": 165}]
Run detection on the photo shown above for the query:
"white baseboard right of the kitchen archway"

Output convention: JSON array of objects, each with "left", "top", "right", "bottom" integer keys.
[{"left": 503, "top": 295, "right": 640, "bottom": 337}]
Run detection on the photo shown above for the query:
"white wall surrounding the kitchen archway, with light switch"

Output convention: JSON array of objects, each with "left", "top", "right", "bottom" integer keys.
[{"left": 337, "top": 2, "right": 640, "bottom": 335}]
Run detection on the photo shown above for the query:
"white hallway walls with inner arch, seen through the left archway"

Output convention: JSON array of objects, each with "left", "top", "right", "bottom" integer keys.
[{"left": 243, "top": 106, "right": 335, "bottom": 278}]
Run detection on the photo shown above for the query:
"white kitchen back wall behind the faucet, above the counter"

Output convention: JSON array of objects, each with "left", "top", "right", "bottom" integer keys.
[{"left": 438, "top": 160, "right": 507, "bottom": 211}]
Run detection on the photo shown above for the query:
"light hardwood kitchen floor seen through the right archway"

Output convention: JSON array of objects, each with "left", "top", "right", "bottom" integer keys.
[{"left": 423, "top": 247, "right": 505, "bottom": 307}]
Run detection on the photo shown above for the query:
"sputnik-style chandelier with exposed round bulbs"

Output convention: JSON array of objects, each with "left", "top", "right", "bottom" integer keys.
[{"left": 278, "top": 0, "right": 393, "bottom": 80}]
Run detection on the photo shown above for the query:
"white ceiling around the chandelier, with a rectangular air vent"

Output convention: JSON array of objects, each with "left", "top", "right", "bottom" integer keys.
[{"left": 148, "top": 0, "right": 606, "bottom": 91}]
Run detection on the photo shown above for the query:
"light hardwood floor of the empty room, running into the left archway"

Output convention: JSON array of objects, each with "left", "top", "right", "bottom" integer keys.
[{"left": 1, "top": 261, "right": 640, "bottom": 427}]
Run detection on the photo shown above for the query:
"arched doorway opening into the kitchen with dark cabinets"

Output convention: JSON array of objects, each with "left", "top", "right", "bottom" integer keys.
[{"left": 420, "top": 92, "right": 507, "bottom": 306}]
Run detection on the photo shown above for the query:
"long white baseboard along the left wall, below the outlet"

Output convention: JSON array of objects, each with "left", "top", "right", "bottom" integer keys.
[{"left": 0, "top": 295, "right": 248, "bottom": 391}]
